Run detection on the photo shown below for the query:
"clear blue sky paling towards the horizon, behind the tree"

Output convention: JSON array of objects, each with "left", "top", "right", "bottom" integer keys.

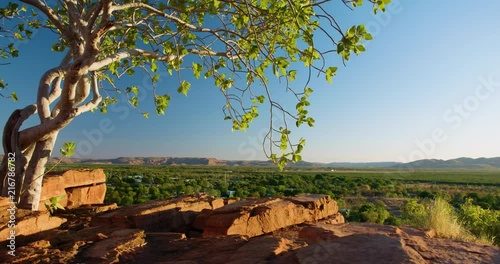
[{"left": 0, "top": 0, "right": 500, "bottom": 162}]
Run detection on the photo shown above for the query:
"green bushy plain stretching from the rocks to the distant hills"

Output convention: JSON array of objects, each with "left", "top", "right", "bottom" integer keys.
[{"left": 55, "top": 164, "right": 500, "bottom": 245}]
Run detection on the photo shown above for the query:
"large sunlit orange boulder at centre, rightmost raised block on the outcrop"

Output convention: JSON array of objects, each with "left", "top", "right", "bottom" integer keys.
[{"left": 197, "top": 194, "right": 338, "bottom": 237}]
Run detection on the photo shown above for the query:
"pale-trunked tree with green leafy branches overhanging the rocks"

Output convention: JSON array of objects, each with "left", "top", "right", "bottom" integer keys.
[{"left": 0, "top": 0, "right": 390, "bottom": 210}]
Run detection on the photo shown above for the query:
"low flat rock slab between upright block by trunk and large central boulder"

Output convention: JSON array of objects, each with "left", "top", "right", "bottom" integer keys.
[{"left": 91, "top": 195, "right": 224, "bottom": 232}]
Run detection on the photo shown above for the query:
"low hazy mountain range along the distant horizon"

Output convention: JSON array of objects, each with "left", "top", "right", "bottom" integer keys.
[{"left": 0, "top": 156, "right": 500, "bottom": 169}]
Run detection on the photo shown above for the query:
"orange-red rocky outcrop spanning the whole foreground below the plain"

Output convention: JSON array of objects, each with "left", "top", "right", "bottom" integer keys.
[{"left": 0, "top": 172, "right": 500, "bottom": 264}]
